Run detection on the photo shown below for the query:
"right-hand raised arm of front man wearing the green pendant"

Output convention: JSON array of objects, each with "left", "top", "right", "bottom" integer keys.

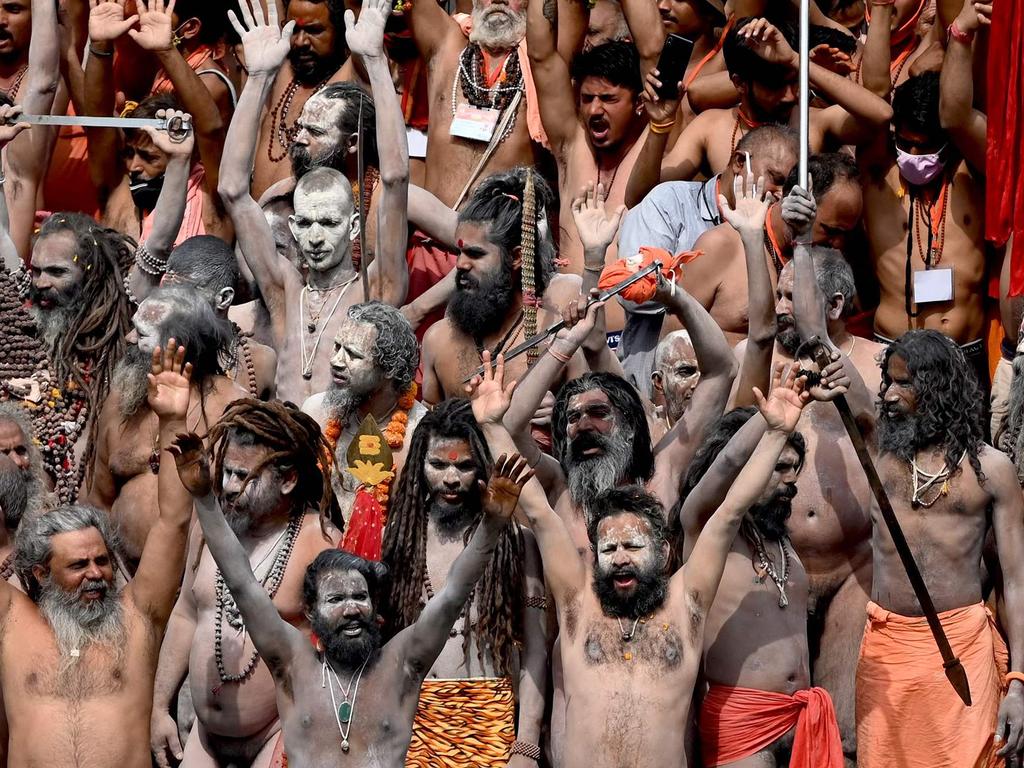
[{"left": 402, "top": 454, "right": 534, "bottom": 677}]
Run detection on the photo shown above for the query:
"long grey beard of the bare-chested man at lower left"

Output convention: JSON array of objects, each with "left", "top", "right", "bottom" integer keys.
[{"left": 39, "top": 581, "right": 127, "bottom": 666}]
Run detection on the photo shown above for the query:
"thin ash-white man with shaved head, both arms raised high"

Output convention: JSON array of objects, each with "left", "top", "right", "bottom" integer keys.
[{"left": 220, "top": 0, "right": 409, "bottom": 402}]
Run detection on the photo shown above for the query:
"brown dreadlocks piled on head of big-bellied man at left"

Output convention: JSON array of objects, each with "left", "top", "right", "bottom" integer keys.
[{"left": 207, "top": 397, "right": 340, "bottom": 538}]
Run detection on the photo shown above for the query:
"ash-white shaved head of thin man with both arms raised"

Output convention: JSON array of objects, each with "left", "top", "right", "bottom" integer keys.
[{"left": 288, "top": 168, "right": 358, "bottom": 272}]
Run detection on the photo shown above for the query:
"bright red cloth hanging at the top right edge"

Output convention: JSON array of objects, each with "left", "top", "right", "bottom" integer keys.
[{"left": 985, "top": 0, "right": 1024, "bottom": 296}]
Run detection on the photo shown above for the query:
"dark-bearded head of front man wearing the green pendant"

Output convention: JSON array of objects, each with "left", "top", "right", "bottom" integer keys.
[{"left": 302, "top": 549, "right": 387, "bottom": 671}]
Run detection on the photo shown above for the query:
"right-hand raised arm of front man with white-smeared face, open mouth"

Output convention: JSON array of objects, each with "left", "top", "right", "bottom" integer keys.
[{"left": 673, "top": 364, "right": 809, "bottom": 615}]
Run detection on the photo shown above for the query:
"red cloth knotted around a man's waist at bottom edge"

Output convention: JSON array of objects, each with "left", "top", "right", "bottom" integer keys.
[{"left": 699, "top": 685, "right": 844, "bottom": 768}]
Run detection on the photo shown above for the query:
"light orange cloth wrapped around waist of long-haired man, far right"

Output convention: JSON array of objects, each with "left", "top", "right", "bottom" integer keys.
[{"left": 857, "top": 602, "right": 1008, "bottom": 768}]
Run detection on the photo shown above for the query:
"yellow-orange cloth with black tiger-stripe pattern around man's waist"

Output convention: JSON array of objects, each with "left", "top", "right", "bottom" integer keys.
[{"left": 406, "top": 678, "right": 515, "bottom": 768}]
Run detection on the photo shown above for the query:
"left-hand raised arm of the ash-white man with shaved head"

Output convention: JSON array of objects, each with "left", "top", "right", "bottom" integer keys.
[{"left": 218, "top": 0, "right": 295, "bottom": 305}]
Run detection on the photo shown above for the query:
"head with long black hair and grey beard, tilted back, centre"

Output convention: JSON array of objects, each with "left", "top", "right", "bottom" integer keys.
[{"left": 551, "top": 373, "right": 654, "bottom": 509}]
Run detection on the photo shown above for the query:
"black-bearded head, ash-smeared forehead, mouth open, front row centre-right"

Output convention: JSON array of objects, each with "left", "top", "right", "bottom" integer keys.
[{"left": 587, "top": 485, "right": 669, "bottom": 618}]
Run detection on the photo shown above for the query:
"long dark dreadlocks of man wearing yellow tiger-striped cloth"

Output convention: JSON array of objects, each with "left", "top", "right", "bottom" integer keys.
[{"left": 383, "top": 399, "right": 525, "bottom": 675}]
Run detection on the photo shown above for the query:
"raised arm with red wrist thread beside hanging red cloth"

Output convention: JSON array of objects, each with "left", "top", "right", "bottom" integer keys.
[{"left": 939, "top": 0, "right": 992, "bottom": 173}]
